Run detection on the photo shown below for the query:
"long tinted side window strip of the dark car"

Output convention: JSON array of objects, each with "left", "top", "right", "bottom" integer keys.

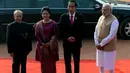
[{"left": 0, "top": 0, "right": 93, "bottom": 8}]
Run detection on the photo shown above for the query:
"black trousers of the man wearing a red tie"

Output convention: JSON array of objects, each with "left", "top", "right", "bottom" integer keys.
[{"left": 64, "top": 45, "right": 80, "bottom": 73}]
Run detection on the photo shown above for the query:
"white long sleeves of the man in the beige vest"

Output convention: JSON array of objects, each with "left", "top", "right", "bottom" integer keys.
[{"left": 94, "top": 19, "right": 119, "bottom": 47}]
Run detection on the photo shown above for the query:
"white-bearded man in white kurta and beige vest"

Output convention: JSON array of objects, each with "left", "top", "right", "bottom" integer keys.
[{"left": 94, "top": 4, "right": 119, "bottom": 73}]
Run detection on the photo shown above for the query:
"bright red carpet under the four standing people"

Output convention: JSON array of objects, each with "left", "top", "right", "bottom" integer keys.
[{"left": 0, "top": 58, "right": 130, "bottom": 73}]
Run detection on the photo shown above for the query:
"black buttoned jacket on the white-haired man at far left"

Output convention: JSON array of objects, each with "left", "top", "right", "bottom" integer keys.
[{"left": 7, "top": 21, "right": 32, "bottom": 54}]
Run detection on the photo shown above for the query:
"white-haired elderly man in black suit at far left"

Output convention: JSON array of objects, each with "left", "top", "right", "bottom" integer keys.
[{"left": 7, "top": 10, "right": 32, "bottom": 73}]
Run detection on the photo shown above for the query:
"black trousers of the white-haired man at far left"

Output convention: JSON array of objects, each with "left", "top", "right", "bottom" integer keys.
[{"left": 12, "top": 53, "right": 27, "bottom": 73}]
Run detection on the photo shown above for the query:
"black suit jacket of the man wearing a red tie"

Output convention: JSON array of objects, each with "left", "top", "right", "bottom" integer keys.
[{"left": 59, "top": 12, "right": 84, "bottom": 47}]
